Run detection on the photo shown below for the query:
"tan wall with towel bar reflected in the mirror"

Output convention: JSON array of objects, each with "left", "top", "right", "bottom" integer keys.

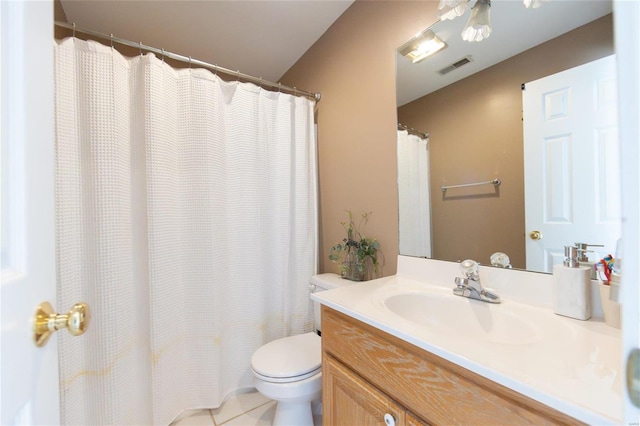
[{"left": 398, "top": 14, "right": 614, "bottom": 269}]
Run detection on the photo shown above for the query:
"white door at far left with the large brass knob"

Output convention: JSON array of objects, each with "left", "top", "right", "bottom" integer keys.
[{"left": 0, "top": 1, "right": 59, "bottom": 425}]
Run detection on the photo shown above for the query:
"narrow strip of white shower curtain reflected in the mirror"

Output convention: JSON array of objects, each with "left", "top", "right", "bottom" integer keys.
[{"left": 398, "top": 130, "right": 431, "bottom": 257}]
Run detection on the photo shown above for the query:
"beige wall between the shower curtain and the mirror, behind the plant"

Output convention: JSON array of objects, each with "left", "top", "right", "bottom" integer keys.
[{"left": 282, "top": 1, "right": 438, "bottom": 276}]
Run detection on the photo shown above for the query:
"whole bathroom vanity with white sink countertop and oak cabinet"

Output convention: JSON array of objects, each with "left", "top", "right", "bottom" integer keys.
[{"left": 313, "top": 256, "right": 622, "bottom": 426}]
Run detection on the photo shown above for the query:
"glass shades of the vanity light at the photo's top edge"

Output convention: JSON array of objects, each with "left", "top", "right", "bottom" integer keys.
[{"left": 437, "top": 0, "right": 548, "bottom": 41}]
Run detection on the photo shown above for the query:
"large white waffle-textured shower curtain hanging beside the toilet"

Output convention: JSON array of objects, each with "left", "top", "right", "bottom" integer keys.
[{"left": 55, "top": 39, "right": 317, "bottom": 425}]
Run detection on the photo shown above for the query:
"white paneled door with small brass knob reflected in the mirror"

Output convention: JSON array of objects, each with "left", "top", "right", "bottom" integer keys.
[{"left": 522, "top": 55, "right": 621, "bottom": 272}]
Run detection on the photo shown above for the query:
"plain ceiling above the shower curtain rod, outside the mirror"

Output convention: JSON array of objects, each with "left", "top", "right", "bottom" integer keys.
[{"left": 61, "top": 0, "right": 353, "bottom": 83}]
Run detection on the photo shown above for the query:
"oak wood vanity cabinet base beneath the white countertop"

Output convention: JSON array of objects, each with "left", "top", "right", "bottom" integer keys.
[{"left": 322, "top": 306, "right": 582, "bottom": 426}]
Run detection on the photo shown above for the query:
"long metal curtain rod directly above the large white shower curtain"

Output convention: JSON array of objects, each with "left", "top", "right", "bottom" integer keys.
[{"left": 54, "top": 21, "right": 321, "bottom": 102}]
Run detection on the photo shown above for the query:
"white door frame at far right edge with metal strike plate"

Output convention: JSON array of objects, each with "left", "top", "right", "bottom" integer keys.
[{"left": 613, "top": 1, "right": 640, "bottom": 425}]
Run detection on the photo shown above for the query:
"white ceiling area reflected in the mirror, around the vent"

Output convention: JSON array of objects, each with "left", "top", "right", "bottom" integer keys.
[{"left": 396, "top": 0, "right": 612, "bottom": 106}]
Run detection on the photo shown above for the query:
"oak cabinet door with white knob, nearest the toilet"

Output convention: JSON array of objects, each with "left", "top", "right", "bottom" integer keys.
[{"left": 322, "top": 355, "right": 405, "bottom": 426}]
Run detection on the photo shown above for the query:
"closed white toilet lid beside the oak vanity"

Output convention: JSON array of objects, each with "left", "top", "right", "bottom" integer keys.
[{"left": 251, "top": 332, "right": 322, "bottom": 379}]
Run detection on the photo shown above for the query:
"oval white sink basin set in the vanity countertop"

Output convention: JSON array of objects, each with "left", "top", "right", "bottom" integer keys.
[{"left": 384, "top": 293, "right": 542, "bottom": 345}]
